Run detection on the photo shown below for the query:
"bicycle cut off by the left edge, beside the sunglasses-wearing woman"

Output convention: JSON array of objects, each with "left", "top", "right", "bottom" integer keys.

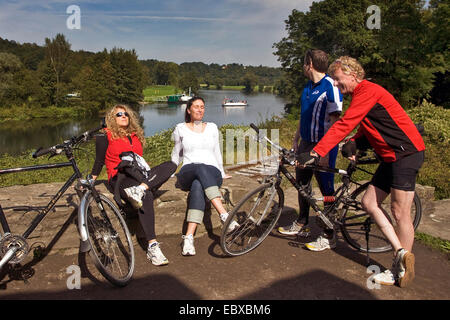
[{"left": 0, "top": 126, "right": 135, "bottom": 287}]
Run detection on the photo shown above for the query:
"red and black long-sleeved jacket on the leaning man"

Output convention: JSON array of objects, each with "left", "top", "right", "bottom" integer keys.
[{"left": 314, "top": 80, "right": 425, "bottom": 162}]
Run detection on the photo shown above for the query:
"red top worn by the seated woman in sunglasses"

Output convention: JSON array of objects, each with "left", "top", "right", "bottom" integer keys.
[{"left": 105, "top": 129, "right": 143, "bottom": 180}]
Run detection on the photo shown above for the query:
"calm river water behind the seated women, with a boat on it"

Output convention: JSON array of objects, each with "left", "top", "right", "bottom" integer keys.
[{"left": 0, "top": 90, "right": 285, "bottom": 154}]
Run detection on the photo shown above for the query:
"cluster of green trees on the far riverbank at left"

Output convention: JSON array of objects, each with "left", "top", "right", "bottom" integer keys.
[{"left": 0, "top": 34, "right": 146, "bottom": 121}]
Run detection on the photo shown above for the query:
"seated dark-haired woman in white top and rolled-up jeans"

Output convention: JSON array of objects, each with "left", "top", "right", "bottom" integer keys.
[{"left": 172, "top": 97, "right": 236, "bottom": 256}]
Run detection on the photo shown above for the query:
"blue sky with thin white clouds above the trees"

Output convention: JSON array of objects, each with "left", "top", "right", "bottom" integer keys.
[{"left": 0, "top": 0, "right": 313, "bottom": 67}]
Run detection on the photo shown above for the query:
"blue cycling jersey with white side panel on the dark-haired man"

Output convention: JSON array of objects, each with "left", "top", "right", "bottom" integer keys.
[{"left": 300, "top": 75, "right": 342, "bottom": 142}]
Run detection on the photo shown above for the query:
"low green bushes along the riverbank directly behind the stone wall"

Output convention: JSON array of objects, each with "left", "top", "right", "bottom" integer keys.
[{"left": 0, "top": 104, "right": 450, "bottom": 199}]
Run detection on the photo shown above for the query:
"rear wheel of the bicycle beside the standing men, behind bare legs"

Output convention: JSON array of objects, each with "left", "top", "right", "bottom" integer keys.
[{"left": 341, "top": 182, "right": 422, "bottom": 253}]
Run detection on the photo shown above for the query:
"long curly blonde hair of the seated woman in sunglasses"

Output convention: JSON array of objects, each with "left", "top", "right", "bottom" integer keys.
[{"left": 105, "top": 104, "right": 145, "bottom": 147}]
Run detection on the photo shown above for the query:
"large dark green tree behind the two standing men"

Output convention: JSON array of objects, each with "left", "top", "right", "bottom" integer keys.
[{"left": 274, "top": 0, "right": 450, "bottom": 109}]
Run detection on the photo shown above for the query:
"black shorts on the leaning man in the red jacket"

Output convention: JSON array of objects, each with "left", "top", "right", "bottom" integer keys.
[{"left": 370, "top": 151, "right": 425, "bottom": 193}]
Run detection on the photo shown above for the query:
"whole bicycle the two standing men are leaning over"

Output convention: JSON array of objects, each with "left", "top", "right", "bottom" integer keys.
[{"left": 220, "top": 124, "right": 422, "bottom": 259}]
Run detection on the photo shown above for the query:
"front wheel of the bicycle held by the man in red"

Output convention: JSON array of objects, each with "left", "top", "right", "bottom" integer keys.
[{"left": 220, "top": 184, "right": 284, "bottom": 256}]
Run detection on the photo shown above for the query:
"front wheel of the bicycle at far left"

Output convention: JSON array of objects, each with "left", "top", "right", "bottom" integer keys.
[{"left": 83, "top": 194, "right": 134, "bottom": 287}]
